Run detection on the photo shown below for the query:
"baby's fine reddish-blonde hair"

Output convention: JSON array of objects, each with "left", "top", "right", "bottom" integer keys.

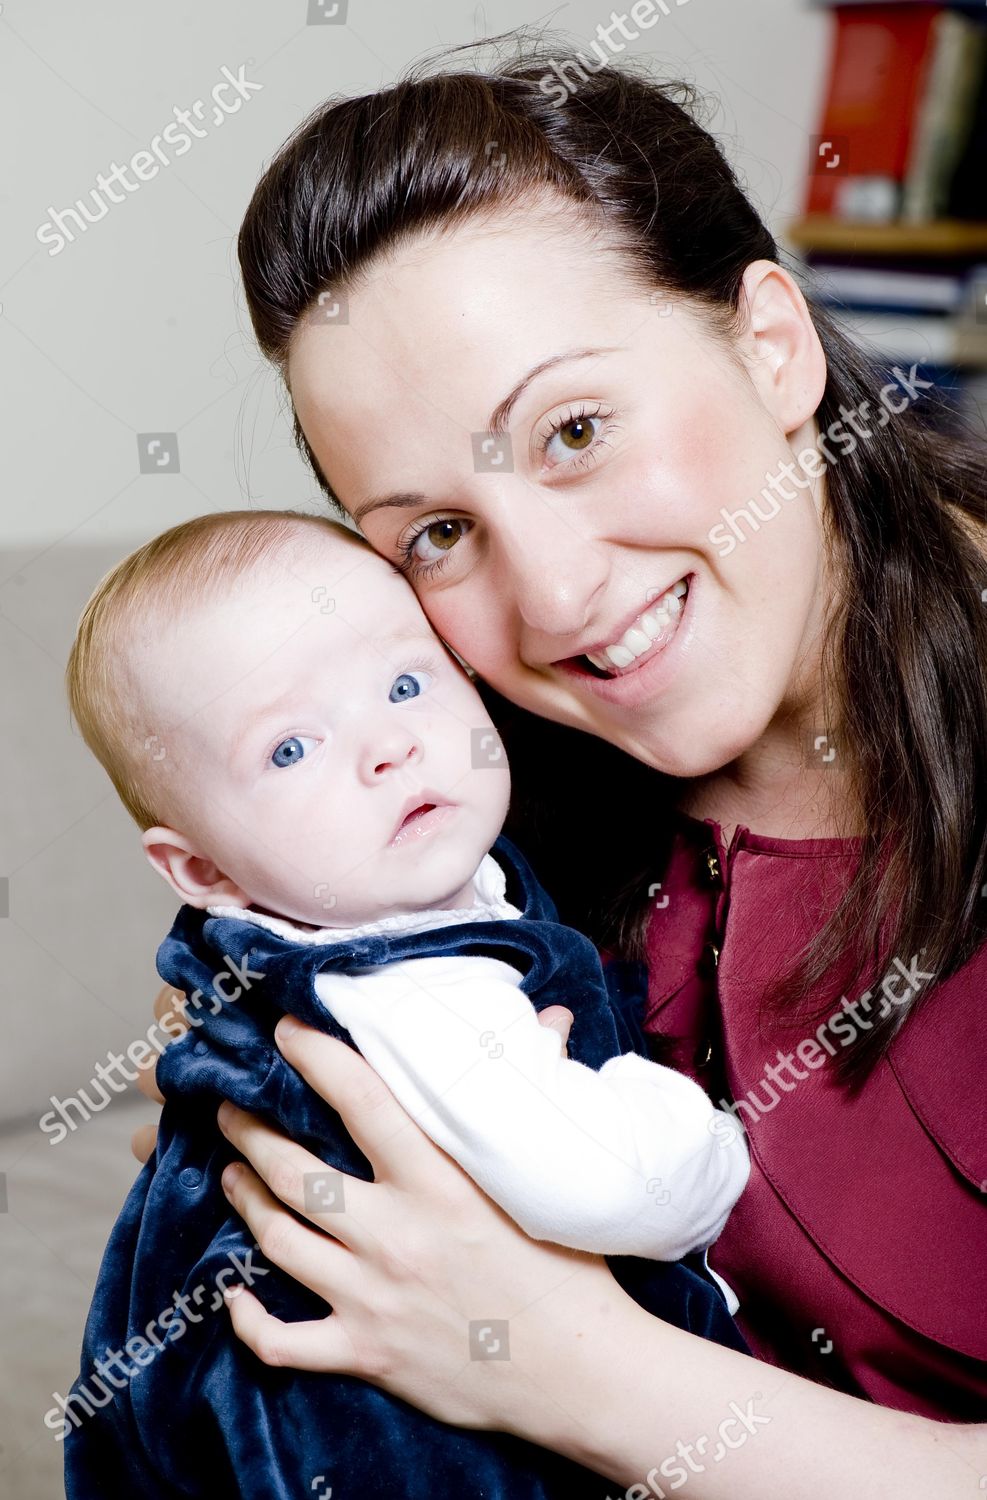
[{"left": 66, "top": 510, "right": 371, "bottom": 830}]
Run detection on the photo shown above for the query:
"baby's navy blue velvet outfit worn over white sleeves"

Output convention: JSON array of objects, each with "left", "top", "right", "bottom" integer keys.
[{"left": 65, "top": 837, "right": 747, "bottom": 1500}]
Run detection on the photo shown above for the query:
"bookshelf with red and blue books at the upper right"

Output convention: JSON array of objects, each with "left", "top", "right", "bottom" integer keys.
[{"left": 785, "top": 0, "right": 987, "bottom": 428}]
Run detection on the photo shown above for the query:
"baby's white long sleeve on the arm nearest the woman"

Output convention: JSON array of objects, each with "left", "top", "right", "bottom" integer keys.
[{"left": 315, "top": 956, "right": 750, "bottom": 1260}]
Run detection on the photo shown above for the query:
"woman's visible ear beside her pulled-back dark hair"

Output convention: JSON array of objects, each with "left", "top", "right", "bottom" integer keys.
[{"left": 729, "top": 261, "right": 827, "bottom": 437}]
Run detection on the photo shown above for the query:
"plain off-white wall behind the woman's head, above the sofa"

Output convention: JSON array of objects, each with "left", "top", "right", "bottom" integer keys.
[{"left": 0, "top": 0, "right": 827, "bottom": 555}]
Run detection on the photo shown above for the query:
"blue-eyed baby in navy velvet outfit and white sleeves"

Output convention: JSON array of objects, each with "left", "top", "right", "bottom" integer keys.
[{"left": 66, "top": 512, "right": 749, "bottom": 1497}]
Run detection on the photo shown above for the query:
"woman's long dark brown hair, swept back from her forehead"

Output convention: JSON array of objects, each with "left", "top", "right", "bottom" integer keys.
[{"left": 232, "top": 23, "right": 987, "bottom": 1083}]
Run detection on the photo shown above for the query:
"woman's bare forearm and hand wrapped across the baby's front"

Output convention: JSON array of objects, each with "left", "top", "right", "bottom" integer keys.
[{"left": 211, "top": 1013, "right": 987, "bottom": 1500}]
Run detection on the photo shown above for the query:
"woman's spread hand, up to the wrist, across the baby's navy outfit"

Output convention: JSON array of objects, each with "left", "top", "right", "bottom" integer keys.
[{"left": 219, "top": 1011, "right": 624, "bottom": 1428}]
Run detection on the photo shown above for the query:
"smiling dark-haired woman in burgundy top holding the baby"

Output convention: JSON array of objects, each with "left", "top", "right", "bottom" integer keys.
[{"left": 136, "top": 32, "right": 987, "bottom": 1500}]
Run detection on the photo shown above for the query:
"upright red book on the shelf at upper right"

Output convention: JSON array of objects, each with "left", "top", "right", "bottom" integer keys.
[{"left": 807, "top": 3, "right": 944, "bottom": 219}]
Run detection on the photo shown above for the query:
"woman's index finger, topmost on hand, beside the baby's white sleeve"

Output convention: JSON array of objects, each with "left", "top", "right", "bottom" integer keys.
[{"left": 271, "top": 1016, "right": 461, "bottom": 1190}]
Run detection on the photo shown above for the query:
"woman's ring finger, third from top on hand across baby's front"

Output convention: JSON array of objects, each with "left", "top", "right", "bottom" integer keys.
[{"left": 222, "top": 1163, "right": 354, "bottom": 1304}]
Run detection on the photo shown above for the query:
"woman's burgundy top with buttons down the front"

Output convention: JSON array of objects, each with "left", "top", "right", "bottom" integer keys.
[{"left": 645, "top": 813, "right": 987, "bottom": 1421}]
